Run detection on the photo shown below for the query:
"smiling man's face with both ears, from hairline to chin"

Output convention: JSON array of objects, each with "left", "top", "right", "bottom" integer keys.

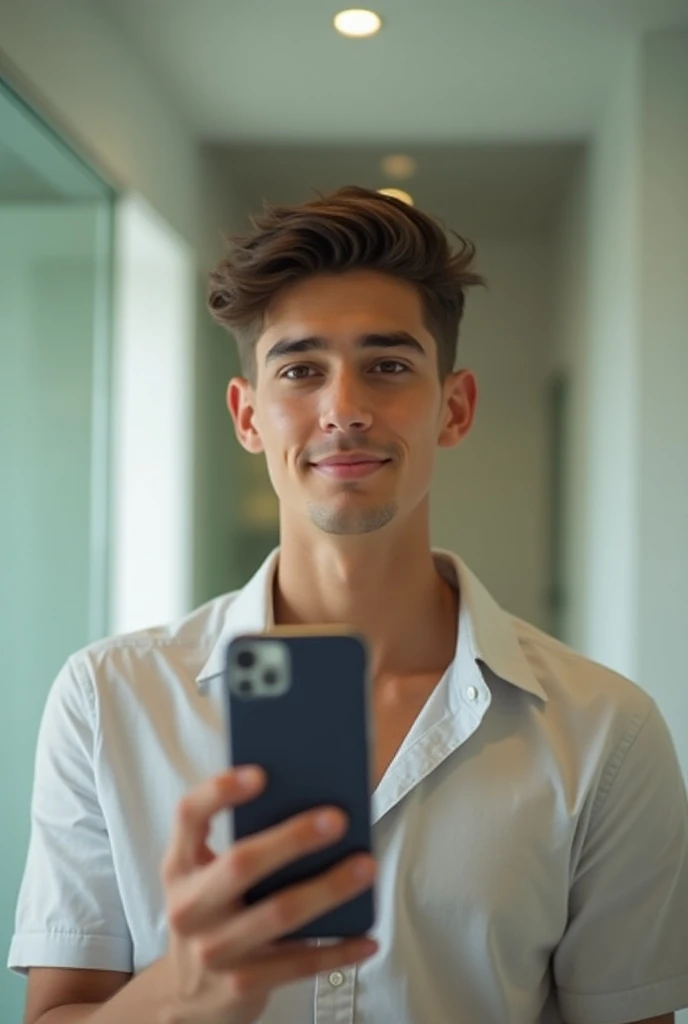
[{"left": 228, "top": 270, "right": 475, "bottom": 535}]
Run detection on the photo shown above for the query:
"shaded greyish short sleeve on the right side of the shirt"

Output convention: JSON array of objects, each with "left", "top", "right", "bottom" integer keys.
[{"left": 553, "top": 702, "right": 688, "bottom": 1024}]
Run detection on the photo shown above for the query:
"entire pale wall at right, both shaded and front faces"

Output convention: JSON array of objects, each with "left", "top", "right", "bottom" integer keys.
[{"left": 555, "top": 32, "right": 688, "bottom": 774}]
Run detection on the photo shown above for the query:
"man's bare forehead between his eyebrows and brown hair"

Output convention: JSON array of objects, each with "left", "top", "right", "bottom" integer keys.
[{"left": 258, "top": 270, "right": 432, "bottom": 346}]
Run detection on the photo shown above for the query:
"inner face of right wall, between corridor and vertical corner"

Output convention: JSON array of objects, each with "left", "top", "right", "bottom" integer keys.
[{"left": 555, "top": 47, "right": 639, "bottom": 676}]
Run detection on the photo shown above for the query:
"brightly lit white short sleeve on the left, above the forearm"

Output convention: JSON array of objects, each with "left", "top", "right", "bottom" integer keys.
[{"left": 8, "top": 660, "right": 132, "bottom": 973}]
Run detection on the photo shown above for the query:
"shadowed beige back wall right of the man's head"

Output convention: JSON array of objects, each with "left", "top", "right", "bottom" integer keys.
[{"left": 432, "top": 236, "right": 553, "bottom": 628}]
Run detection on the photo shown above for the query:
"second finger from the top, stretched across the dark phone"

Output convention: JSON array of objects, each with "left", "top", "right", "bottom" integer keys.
[{"left": 168, "top": 808, "right": 347, "bottom": 935}]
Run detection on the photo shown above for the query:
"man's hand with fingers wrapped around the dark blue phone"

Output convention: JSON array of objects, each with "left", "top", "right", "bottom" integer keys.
[{"left": 162, "top": 767, "right": 377, "bottom": 1024}]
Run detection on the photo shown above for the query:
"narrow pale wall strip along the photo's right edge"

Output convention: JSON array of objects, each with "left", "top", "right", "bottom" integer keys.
[{"left": 637, "top": 31, "right": 688, "bottom": 776}]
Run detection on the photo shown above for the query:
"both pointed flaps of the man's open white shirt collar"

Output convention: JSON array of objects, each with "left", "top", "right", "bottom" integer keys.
[{"left": 196, "top": 548, "right": 547, "bottom": 700}]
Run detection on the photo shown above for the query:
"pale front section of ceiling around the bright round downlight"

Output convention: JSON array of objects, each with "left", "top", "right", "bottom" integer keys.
[{"left": 91, "top": 0, "right": 688, "bottom": 143}]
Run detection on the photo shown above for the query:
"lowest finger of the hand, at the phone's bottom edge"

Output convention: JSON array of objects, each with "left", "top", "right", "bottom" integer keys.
[{"left": 225, "top": 938, "right": 379, "bottom": 998}]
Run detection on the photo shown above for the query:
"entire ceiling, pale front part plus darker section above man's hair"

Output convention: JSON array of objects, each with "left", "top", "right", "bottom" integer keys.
[{"left": 90, "top": 0, "right": 688, "bottom": 236}]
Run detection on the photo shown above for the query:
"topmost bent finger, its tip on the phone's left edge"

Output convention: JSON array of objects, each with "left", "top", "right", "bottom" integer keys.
[{"left": 162, "top": 765, "right": 265, "bottom": 882}]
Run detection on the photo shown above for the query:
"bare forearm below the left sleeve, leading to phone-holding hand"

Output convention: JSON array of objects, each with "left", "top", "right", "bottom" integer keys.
[{"left": 36, "top": 957, "right": 171, "bottom": 1024}]
